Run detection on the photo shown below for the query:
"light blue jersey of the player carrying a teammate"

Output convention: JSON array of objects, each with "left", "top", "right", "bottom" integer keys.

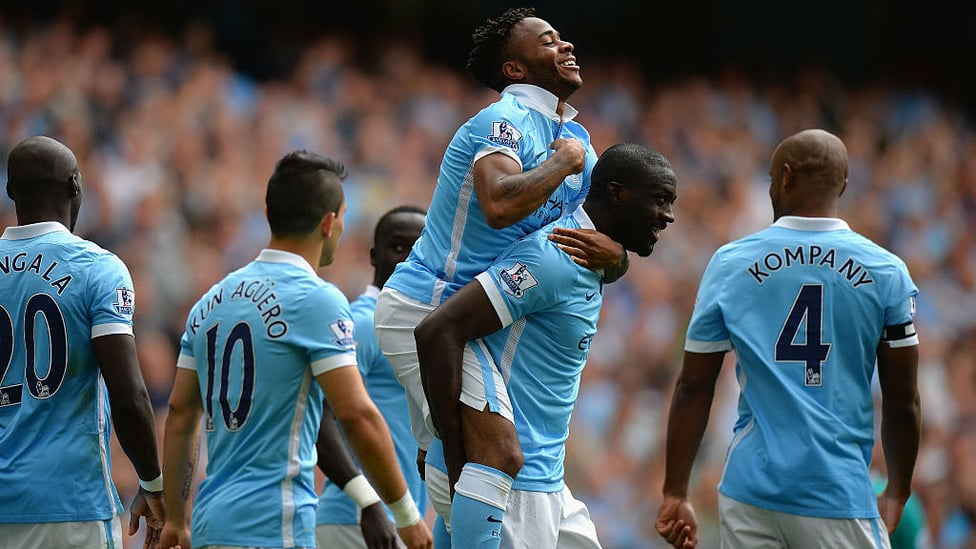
[{"left": 468, "top": 208, "right": 603, "bottom": 492}]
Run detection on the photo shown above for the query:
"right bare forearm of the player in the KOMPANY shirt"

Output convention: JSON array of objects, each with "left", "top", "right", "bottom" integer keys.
[{"left": 881, "top": 395, "right": 921, "bottom": 499}]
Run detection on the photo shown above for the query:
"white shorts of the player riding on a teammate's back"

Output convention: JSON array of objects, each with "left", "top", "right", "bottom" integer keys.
[{"left": 373, "top": 288, "right": 515, "bottom": 450}]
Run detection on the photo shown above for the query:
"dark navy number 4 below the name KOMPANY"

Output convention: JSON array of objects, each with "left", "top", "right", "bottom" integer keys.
[{"left": 774, "top": 284, "right": 830, "bottom": 387}]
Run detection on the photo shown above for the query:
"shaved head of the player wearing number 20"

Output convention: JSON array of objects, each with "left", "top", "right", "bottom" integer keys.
[{"left": 7, "top": 135, "right": 81, "bottom": 229}]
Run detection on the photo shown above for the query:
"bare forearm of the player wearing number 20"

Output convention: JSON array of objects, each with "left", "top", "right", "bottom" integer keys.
[{"left": 109, "top": 386, "right": 161, "bottom": 480}]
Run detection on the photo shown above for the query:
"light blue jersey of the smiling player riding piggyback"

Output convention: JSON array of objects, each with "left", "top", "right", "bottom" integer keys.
[{"left": 385, "top": 84, "right": 597, "bottom": 305}]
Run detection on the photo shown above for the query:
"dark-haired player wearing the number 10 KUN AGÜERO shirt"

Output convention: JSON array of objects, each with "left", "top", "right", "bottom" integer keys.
[{"left": 160, "top": 151, "right": 431, "bottom": 548}]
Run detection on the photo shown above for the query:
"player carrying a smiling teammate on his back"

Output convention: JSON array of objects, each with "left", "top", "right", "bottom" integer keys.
[{"left": 417, "top": 144, "right": 677, "bottom": 549}]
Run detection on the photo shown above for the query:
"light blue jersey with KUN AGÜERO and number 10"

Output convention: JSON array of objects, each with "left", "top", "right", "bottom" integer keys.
[{"left": 177, "top": 249, "right": 356, "bottom": 547}]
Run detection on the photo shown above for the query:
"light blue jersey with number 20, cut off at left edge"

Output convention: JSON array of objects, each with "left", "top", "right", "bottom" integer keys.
[{"left": 0, "top": 222, "right": 135, "bottom": 520}]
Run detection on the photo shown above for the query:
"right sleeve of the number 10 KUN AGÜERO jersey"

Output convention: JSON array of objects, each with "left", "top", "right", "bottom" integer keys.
[{"left": 296, "top": 286, "right": 356, "bottom": 375}]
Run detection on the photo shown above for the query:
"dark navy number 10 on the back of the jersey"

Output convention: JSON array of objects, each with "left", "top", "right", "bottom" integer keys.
[{"left": 204, "top": 322, "right": 254, "bottom": 431}]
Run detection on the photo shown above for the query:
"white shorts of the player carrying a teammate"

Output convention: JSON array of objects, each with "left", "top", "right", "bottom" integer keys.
[{"left": 501, "top": 487, "right": 601, "bottom": 549}]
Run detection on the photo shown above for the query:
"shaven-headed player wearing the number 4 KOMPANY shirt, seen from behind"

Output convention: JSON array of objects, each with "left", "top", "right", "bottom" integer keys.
[{"left": 656, "top": 130, "right": 920, "bottom": 548}]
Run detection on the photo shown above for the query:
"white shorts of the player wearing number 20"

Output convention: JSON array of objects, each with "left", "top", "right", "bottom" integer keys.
[{"left": 0, "top": 517, "right": 124, "bottom": 549}]
